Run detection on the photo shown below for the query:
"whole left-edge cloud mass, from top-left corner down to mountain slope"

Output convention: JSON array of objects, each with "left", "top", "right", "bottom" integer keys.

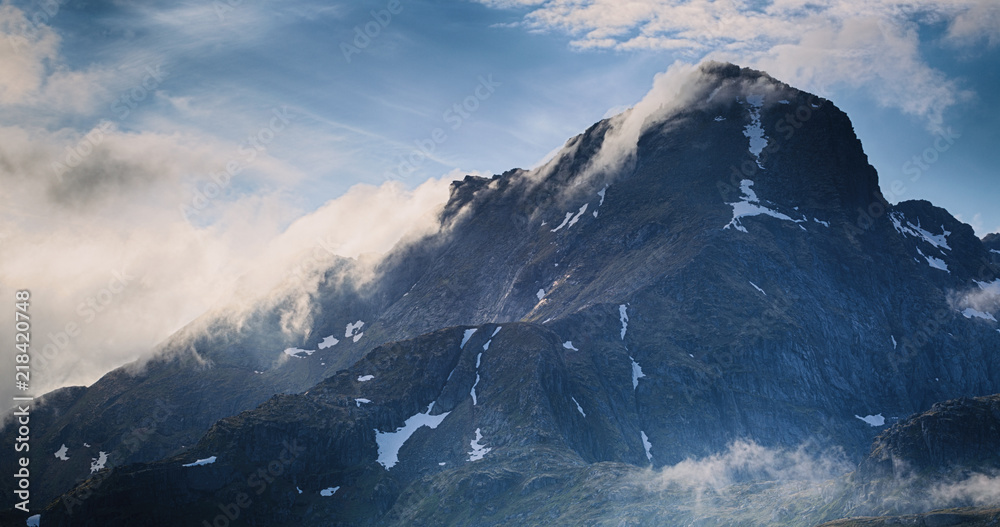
[{"left": 0, "top": 5, "right": 450, "bottom": 400}]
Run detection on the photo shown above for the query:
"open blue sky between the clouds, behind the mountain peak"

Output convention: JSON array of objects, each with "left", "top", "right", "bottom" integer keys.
[{"left": 3, "top": 0, "right": 1000, "bottom": 227}]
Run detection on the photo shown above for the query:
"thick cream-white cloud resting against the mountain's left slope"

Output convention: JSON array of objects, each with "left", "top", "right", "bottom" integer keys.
[{"left": 0, "top": 104, "right": 450, "bottom": 404}]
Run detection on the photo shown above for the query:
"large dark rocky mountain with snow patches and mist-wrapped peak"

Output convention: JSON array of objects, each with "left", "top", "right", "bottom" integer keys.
[{"left": 4, "top": 63, "right": 1000, "bottom": 525}]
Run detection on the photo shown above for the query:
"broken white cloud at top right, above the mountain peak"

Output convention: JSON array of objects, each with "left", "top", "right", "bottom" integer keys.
[{"left": 481, "top": 0, "right": 1000, "bottom": 128}]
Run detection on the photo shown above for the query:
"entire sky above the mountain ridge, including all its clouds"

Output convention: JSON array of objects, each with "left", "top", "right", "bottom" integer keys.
[{"left": 0, "top": 0, "right": 1000, "bottom": 396}]
